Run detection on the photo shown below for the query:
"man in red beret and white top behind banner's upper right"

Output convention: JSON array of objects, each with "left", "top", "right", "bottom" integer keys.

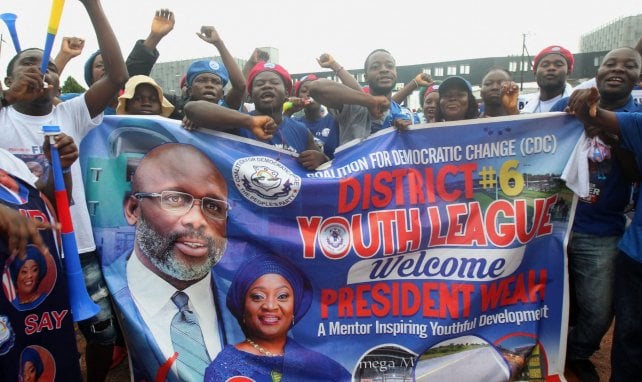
[{"left": 522, "top": 45, "right": 574, "bottom": 113}]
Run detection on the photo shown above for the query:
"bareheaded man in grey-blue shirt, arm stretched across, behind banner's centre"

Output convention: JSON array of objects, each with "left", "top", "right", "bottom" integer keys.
[{"left": 310, "top": 49, "right": 412, "bottom": 144}]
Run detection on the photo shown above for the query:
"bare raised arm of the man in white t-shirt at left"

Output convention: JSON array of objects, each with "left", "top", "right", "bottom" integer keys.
[{"left": 80, "top": 0, "right": 128, "bottom": 118}]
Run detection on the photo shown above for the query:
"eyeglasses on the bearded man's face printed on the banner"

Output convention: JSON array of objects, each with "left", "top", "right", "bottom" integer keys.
[{"left": 134, "top": 191, "right": 230, "bottom": 220}]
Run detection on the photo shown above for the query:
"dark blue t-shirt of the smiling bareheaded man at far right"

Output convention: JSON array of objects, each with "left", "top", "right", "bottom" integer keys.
[{"left": 551, "top": 97, "right": 640, "bottom": 236}]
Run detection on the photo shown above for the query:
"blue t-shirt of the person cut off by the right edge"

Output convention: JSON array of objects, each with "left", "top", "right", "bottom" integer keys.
[{"left": 617, "top": 113, "right": 642, "bottom": 262}]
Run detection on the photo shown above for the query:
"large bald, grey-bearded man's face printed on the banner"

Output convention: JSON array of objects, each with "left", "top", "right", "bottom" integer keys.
[{"left": 125, "top": 144, "right": 227, "bottom": 281}]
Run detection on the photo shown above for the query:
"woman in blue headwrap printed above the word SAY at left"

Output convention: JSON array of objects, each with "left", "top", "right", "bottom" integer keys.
[{"left": 9, "top": 245, "right": 47, "bottom": 305}]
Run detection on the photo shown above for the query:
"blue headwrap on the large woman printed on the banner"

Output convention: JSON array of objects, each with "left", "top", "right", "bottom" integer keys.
[{"left": 227, "top": 254, "right": 312, "bottom": 326}]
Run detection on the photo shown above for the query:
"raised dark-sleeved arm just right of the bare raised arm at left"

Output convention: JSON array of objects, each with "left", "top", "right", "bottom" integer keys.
[{"left": 126, "top": 9, "right": 176, "bottom": 76}]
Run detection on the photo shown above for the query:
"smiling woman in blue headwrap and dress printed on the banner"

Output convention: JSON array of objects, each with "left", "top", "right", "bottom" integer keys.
[{"left": 205, "top": 255, "right": 352, "bottom": 382}]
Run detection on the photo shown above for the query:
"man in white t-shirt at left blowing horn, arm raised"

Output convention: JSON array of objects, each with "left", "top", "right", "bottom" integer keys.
[{"left": 0, "top": 0, "right": 127, "bottom": 381}]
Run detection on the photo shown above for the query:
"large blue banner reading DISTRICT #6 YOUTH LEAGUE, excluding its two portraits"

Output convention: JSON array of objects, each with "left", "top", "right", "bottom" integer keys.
[{"left": 81, "top": 113, "right": 582, "bottom": 381}]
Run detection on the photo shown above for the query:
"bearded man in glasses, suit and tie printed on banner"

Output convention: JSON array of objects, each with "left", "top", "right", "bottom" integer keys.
[{"left": 105, "top": 143, "right": 228, "bottom": 381}]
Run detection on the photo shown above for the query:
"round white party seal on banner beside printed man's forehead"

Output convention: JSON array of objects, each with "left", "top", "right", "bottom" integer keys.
[{"left": 232, "top": 156, "right": 301, "bottom": 207}]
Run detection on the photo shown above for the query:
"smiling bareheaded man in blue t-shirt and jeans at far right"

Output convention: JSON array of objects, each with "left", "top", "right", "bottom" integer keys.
[{"left": 551, "top": 48, "right": 642, "bottom": 381}]
